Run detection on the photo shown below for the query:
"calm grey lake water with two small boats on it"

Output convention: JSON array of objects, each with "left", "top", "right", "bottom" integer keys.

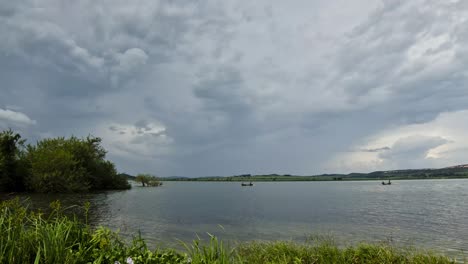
[{"left": 3, "top": 180, "right": 468, "bottom": 256}]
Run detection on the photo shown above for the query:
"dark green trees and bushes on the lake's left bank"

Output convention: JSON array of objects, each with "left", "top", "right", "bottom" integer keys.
[{"left": 0, "top": 130, "right": 131, "bottom": 193}]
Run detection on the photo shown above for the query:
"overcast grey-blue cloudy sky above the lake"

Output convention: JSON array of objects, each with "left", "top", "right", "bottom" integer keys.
[{"left": 0, "top": 0, "right": 468, "bottom": 176}]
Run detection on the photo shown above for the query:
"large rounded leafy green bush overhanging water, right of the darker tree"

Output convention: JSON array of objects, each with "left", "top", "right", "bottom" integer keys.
[{"left": 28, "top": 136, "right": 130, "bottom": 192}]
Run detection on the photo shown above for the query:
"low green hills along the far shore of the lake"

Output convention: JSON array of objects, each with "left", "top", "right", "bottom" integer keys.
[{"left": 165, "top": 164, "right": 468, "bottom": 182}]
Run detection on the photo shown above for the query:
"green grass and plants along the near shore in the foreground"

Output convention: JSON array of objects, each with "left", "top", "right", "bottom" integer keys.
[{"left": 0, "top": 199, "right": 454, "bottom": 264}]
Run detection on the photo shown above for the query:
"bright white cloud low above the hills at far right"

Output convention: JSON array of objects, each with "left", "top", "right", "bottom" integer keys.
[{"left": 327, "top": 110, "right": 468, "bottom": 172}]
